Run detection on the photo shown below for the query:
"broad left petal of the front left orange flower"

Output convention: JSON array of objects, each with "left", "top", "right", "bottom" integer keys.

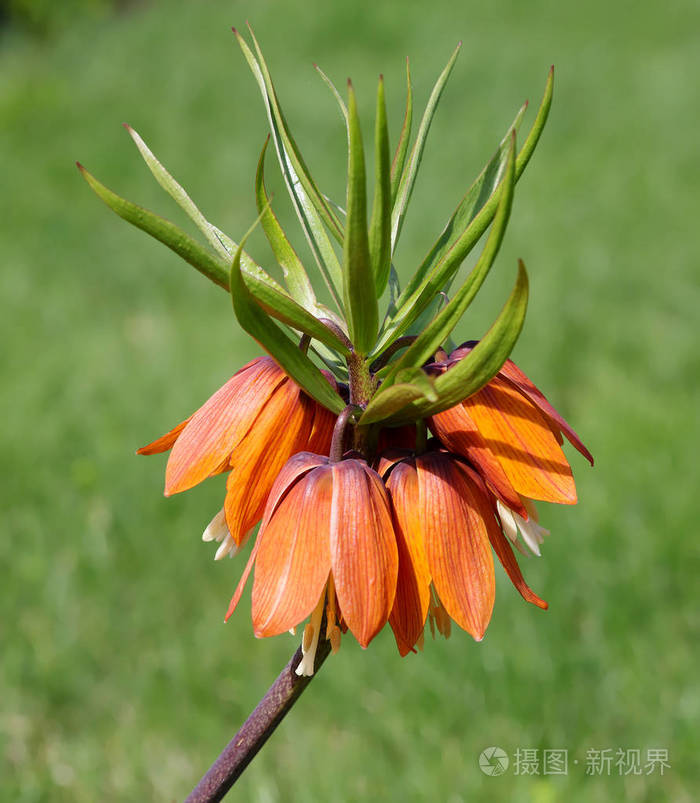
[{"left": 252, "top": 466, "right": 333, "bottom": 636}]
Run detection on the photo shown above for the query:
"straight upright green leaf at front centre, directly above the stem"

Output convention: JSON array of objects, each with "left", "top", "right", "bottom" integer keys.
[{"left": 343, "top": 81, "right": 378, "bottom": 354}]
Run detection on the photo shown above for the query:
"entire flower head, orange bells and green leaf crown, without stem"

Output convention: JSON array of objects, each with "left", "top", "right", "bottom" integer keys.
[{"left": 81, "top": 26, "right": 592, "bottom": 675}]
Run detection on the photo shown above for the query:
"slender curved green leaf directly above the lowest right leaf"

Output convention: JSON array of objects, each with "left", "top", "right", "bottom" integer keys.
[{"left": 386, "top": 131, "right": 515, "bottom": 384}]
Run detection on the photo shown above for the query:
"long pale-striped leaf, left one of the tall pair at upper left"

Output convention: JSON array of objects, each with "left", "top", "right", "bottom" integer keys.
[{"left": 234, "top": 29, "right": 343, "bottom": 309}]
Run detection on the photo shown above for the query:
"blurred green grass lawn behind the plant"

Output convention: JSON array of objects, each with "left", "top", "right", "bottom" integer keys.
[{"left": 0, "top": 0, "right": 700, "bottom": 803}]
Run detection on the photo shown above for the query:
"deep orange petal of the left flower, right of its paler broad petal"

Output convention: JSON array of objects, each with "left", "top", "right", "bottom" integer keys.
[{"left": 224, "top": 382, "right": 314, "bottom": 543}]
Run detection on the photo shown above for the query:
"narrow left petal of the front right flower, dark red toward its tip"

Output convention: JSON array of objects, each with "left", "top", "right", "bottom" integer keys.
[{"left": 387, "top": 461, "right": 430, "bottom": 656}]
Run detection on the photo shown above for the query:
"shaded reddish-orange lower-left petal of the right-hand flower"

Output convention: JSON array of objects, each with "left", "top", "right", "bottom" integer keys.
[{"left": 428, "top": 404, "right": 527, "bottom": 519}]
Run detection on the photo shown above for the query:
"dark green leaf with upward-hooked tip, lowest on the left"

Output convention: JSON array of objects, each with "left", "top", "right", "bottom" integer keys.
[{"left": 230, "top": 215, "right": 345, "bottom": 414}]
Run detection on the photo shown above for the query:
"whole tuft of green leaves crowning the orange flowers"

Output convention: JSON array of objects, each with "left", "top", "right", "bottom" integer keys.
[{"left": 79, "top": 25, "right": 553, "bottom": 425}]
